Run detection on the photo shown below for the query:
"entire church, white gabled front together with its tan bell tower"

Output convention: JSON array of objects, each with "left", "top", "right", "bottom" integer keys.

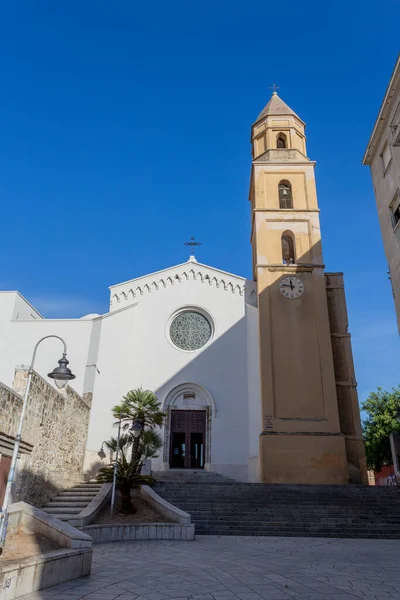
[{"left": 0, "top": 93, "right": 367, "bottom": 484}]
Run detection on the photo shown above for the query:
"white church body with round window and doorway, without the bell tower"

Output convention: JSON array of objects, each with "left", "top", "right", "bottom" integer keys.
[{"left": 0, "top": 255, "right": 261, "bottom": 481}]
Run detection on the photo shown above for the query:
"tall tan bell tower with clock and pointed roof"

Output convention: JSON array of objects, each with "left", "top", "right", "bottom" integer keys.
[{"left": 250, "top": 92, "right": 365, "bottom": 483}]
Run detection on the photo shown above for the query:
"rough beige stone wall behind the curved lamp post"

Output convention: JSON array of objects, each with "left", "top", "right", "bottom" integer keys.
[{"left": 0, "top": 368, "right": 91, "bottom": 506}]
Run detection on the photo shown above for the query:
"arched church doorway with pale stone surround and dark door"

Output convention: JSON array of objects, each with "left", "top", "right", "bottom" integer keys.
[{"left": 163, "top": 383, "right": 216, "bottom": 470}]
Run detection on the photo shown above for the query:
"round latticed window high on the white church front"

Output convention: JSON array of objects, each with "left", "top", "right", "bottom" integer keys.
[{"left": 169, "top": 310, "right": 212, "bottom": 350}]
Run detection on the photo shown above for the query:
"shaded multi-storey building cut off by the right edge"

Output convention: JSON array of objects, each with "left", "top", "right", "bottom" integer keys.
[{"left": 363, "top": 56, "right": 400, "bottom": 332}]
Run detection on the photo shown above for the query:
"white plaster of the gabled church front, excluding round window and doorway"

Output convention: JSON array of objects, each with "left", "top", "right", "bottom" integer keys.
[{"left": 87, "top": 267, "right": 253, "bottom": 480}]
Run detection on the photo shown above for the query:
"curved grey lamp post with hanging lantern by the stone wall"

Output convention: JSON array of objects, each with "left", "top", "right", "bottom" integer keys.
[{"left": 0, "top": 335, "right": 75, "bottom": 555}]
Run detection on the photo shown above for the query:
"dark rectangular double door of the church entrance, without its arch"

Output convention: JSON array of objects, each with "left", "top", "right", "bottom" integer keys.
[{"left": 169, "top": 410, "right": 207, "bottom": 469}]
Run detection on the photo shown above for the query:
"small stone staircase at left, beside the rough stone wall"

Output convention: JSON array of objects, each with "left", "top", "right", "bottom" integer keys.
[{"left": 40, "top": 483, "right": 103, "bottom": 521}]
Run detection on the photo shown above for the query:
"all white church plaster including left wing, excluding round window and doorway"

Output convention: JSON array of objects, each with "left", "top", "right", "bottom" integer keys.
[{"left": 0, "top": 265, "right": 260, "bottom": 481}]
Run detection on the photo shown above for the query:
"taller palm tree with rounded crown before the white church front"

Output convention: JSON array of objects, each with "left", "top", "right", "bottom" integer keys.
[{"left": 113, "top": 388, "right": 165, "bottom": 472}]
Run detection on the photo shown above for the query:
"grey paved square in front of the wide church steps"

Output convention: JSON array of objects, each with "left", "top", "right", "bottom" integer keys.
[{"left": 24, "top": 536, "right": 400, "bottom": 600}]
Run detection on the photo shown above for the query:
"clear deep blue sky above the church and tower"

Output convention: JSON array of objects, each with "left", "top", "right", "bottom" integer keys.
[{"left": 0, "top": 0, "right": 400, "bottom": 399}]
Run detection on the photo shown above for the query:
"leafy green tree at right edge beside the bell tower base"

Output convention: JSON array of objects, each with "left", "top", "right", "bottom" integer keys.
[{"left": 361, "top": 386, "right": 400, "bottom": 471}]
